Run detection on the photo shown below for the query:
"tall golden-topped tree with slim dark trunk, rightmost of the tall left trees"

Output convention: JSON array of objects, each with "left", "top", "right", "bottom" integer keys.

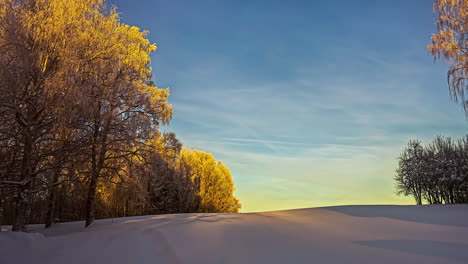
[{"left": 73, "top": 10, "right": 172, "bottom": 225}]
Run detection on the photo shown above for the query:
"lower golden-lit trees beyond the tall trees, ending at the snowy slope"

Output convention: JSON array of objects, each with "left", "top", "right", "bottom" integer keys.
[{"left": 90, "top": 133, "right": 240, "bottom": 217}]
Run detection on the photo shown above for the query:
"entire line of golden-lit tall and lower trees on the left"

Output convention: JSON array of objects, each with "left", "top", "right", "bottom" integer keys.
[{"left": 0, "top": 0, "right": 240, "bottom": 231}]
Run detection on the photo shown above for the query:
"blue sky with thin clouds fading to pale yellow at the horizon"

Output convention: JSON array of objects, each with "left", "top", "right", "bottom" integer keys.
[{"left": 110, "top": 0, "right": 467, "bottom": 212}]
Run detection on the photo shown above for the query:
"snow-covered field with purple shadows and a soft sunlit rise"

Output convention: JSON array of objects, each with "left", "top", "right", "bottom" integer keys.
[{"left": 0, "top": 205, "right": 468, "bottom": 264}]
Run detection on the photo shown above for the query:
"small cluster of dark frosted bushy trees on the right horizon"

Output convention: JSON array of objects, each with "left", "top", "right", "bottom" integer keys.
[{"left": 395, "top": 135, "right": 468, "bottom": 204}]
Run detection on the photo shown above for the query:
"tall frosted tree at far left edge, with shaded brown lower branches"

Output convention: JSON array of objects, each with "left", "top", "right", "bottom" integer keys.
[{"left": 0, "top": 0, "right": 89, "bottom": 230}]
